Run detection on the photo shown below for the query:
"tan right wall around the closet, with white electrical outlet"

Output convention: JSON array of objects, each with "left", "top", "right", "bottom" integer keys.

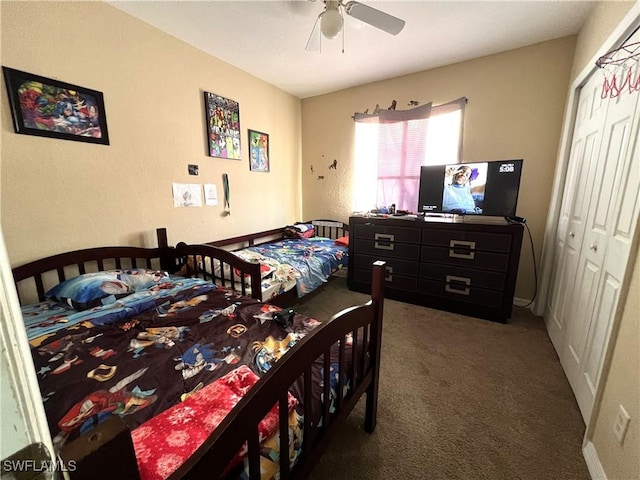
[{"left": 572, "top": 2, "right": 640, "bottom": 480}]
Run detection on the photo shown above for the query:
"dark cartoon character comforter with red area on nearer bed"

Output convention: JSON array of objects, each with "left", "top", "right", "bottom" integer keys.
[{"left": 30, "top": 280, "right": 352, "bottom": 479}]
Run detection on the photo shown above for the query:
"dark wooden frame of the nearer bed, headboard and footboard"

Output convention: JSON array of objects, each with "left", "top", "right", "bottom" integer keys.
[{"left": 13, "top": 229, "right": 384, "bottom": 480}]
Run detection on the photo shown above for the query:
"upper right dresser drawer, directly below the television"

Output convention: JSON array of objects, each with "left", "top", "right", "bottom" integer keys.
[{"left": 422, "top": 229, "right": 511, "bottom": 253}]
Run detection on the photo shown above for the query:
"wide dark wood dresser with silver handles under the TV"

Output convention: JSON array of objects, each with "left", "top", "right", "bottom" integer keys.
[{"left": 348, "top": 216, "right": 523, "bottom": 322}]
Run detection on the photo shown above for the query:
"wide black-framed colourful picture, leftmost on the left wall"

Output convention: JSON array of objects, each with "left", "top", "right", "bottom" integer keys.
[{"left": 2, "top": 67, "right": 109, "bottom": 145}]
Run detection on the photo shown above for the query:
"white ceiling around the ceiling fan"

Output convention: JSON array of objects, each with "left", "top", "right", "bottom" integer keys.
[{"left": 108, "top": 0, "right": 595, "bottom": 98}]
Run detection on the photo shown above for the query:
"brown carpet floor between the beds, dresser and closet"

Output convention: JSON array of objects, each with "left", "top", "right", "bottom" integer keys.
[{"left": 295, "top": 276, "right": 590, "bottom": 480}]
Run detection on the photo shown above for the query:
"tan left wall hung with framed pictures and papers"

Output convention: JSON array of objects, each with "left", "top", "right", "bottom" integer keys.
[{"left": 0, "top": 2, "right": 301, "bottom": 265}]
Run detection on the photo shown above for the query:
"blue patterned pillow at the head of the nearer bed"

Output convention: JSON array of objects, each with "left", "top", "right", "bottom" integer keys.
[{"left": 46, "top": 268, "right": 168, "bottom": 311}]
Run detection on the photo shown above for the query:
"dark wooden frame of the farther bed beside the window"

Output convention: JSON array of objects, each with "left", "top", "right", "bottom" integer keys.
[{"left": 158, "top": 219, "right": 349, "bottom": 308}]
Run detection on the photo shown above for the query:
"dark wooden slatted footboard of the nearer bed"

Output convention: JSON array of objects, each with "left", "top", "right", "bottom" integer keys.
[{"left": 170, "top": 262, "right": 384, "bottom": 480}]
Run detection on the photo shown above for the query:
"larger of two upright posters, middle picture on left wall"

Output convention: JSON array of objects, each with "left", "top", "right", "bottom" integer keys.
[{"left": 204, "top": 92, "right": 240, "bottom": 160}]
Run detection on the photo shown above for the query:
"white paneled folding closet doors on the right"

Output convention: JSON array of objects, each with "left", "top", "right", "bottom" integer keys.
[{"left": 547, "top": 54, "right": 640, "bottom": 422}]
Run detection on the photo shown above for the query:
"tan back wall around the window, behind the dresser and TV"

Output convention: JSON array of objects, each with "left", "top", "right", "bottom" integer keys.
[{"left": 302, "top": 36, "right": 575, "bottom": 298}]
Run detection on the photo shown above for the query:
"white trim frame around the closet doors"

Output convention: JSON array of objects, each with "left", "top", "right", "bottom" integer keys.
[{"left": 532, "top": 0, "right": 640, "bottom": 446}]
